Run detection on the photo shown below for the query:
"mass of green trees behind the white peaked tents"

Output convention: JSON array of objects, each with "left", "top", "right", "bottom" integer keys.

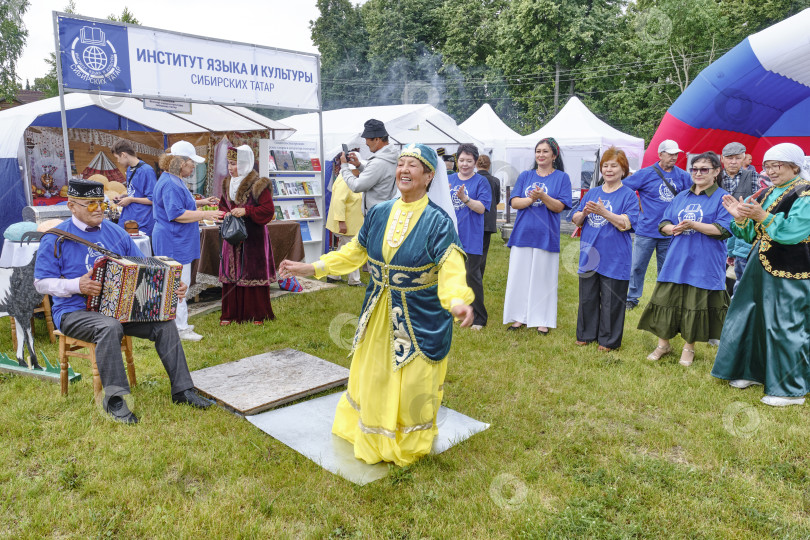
[{"left": 311, "top": 0, "right": 810, "bottom": 140}]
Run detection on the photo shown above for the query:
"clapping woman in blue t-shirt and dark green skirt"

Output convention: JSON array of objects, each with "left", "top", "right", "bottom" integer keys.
[{"left": 638, "top": 152, "right": 731, "bottom": 367}]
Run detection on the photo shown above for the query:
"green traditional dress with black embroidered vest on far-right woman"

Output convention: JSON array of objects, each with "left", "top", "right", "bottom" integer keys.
[{"left": 712, "top": 178, "right": 810, "bottom": 397}]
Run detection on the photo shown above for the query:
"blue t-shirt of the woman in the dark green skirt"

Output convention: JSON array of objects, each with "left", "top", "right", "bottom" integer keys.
[{"left": 658, "top": 184, "right": 731, "bottom": 291}]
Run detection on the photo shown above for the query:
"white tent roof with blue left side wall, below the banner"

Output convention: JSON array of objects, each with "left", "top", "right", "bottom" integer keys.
[{"left": 0, "top": 93, "right": 293, "bottom": 231}]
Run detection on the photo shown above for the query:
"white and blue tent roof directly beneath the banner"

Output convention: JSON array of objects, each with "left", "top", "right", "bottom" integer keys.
[{"left": 0, "top": 93, "right": 293, "bottom": 158}]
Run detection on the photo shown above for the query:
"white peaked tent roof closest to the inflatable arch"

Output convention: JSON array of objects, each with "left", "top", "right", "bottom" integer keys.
[{"left": 523, "top": 96, "right": 644, "bottom": 151}]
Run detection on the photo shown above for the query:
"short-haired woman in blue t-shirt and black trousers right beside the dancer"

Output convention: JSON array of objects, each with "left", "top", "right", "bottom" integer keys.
[{"left": 447, "top": 143, "right": 492, "bottom": 330}]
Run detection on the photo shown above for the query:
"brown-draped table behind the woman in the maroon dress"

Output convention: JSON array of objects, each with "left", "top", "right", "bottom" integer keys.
[{"left": 191, "top": 221, "right": 304, "bottom": 285}]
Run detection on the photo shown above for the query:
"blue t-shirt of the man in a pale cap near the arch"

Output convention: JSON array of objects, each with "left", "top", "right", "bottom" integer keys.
[{"left": 622, "top": 163, "right": 692, "bottom": 238}]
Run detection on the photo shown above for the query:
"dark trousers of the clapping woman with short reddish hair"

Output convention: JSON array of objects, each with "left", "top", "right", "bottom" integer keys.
[{"left": 577, "top": 272, "right": 630, "bottom": 349}]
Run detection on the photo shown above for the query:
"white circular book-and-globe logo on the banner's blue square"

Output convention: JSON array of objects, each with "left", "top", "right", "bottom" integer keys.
[{"left": 70, "top": 26, "right": 121, "bottom": 85}]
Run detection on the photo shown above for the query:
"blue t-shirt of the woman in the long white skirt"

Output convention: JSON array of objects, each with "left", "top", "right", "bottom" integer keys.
[{"left": 507, "top": 169, "right": 572, "bottom": 253}]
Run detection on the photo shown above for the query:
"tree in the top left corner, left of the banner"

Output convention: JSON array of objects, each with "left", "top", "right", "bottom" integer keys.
[{"left": 0, "top": 0, "right": 29, "bottom": 101}]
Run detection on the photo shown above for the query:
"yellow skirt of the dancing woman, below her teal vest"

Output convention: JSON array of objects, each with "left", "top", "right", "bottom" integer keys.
[{"left": 332, "top": 295, "right": 447, "bottom": 467}]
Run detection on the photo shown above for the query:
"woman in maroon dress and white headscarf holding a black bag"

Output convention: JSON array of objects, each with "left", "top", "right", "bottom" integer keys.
[{"left": 219, "top": 145, "right": 276, "bottom": 326}]
